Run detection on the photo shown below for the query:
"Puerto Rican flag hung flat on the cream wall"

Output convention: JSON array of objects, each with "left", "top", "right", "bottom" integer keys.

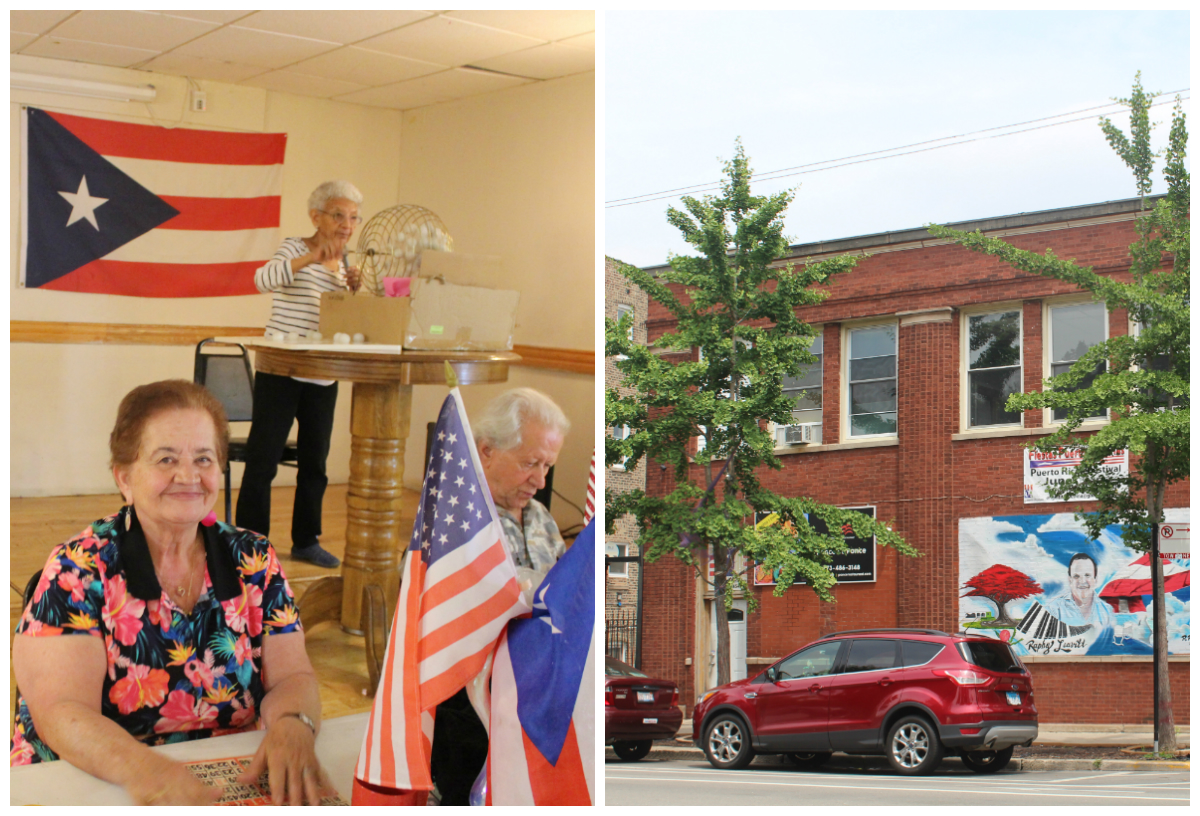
[{"left": 20, "top": 108, "right": 287, "bottom": 298}]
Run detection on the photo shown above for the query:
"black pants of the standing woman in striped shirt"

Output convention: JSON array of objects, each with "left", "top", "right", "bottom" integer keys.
[{"left": 238, "top": 372, "right": 337, "bottom": 548}]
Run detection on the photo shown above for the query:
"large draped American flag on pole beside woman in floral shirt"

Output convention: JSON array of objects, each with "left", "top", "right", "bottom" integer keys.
[{"left": 354, "top": 389, "right": 530, "bottom": 791}]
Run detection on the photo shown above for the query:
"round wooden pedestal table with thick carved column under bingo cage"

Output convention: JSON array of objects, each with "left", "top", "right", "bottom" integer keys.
[{"left": 218, "top": 337, "right": 521, "bottom": 672}]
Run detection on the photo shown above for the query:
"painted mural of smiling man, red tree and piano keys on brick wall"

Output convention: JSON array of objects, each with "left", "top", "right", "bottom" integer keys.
[{"left": 959, "top": 508, "right": 1192, "bottom": 655}]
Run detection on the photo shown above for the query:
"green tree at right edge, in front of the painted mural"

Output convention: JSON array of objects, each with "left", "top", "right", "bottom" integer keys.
[{"left": 930, "top": 73, "right": 1192, "bottom": 751}]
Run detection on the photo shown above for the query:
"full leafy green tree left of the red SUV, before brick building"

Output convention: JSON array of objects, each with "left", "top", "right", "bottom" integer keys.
[{"left": 605, "top": 140, "right": 918, "bottom": 683}]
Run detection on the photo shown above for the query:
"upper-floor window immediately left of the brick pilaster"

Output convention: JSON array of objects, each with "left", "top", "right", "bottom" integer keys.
[{"left": 846, "top": 324, "right": 896, "bottom": 437}]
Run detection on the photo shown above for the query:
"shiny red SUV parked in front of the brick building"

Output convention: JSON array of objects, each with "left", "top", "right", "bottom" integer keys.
[{"left": 692, "top": 629, "right": 1038, "bottom": 775}]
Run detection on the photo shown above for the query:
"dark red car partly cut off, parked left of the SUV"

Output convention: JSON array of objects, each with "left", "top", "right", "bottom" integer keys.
[{"left": 604, "top": 658, "right": 683, "bottom": 762}]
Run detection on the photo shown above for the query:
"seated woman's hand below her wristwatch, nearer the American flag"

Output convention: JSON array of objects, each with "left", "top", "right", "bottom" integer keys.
[{"left": 238, "top": 716, "right": 334, "bottom": 805}]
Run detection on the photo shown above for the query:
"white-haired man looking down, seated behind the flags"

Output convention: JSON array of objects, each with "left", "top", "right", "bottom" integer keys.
[{"left": 430, "top": 388, "right": 570, "bottom": 805}]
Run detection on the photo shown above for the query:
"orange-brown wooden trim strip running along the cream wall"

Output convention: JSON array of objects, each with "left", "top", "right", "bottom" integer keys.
[{"left": 8, "top": 320, "right": 595, "bottom": 376}]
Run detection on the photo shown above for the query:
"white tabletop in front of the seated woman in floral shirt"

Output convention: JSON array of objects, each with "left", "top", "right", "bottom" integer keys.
[{"left": 8, "top": 712, "right": 371, "bottom": 805}]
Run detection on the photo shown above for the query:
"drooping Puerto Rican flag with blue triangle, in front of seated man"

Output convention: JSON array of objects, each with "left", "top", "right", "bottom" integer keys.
[{"left": 487, "top": 521, "right": 596, "bottom": 805}]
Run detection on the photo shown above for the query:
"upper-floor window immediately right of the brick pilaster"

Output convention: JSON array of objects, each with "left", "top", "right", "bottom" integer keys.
[{"left": 966, "top": 310, "right": 1021, "bottom": 428}]
